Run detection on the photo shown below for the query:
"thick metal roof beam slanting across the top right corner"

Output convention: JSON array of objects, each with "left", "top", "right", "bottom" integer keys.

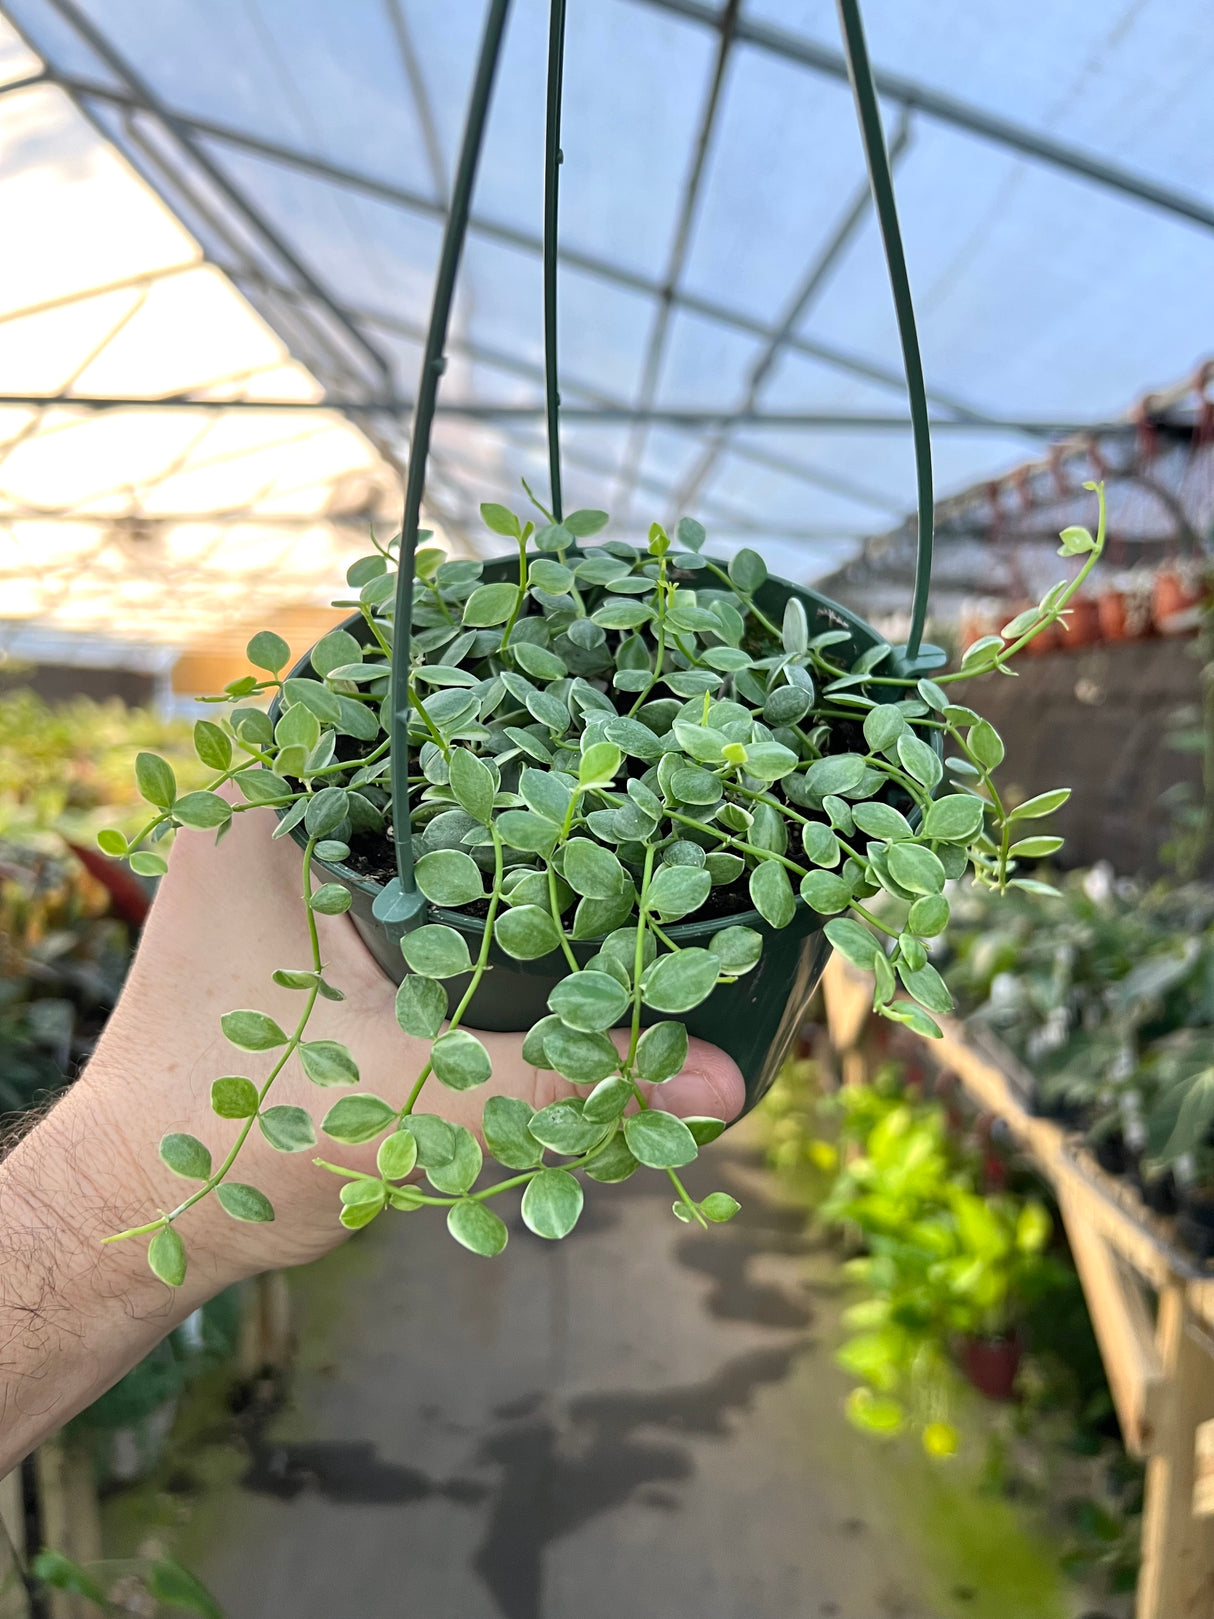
[{"left": 638, "top": 0, "right": 1214, "bottom": 230}]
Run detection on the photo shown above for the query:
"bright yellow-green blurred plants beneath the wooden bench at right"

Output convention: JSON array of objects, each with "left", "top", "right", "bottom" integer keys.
[{"left": 759, "top": 1049, "right": 1143, "bottom": 1595}]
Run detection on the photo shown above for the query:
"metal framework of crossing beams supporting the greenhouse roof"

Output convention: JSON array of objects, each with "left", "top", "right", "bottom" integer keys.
[{"left": 0, "top": 0, "right": 1214, "bottom": 589}]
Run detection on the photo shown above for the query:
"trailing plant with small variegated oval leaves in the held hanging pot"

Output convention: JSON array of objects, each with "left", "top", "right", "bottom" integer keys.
[{"left": 100, "top": 486, "right": 1104, "bottom": 1284}]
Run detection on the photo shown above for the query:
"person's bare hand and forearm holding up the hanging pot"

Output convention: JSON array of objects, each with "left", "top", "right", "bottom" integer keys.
[{"left": 0, "top": 810, "right": 745, "bottom": 1472}]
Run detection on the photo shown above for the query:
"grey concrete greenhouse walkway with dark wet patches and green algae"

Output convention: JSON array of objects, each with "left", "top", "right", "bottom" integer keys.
[{"left": 194, "top": 1138, "right": 1070, "bottom": 1619}]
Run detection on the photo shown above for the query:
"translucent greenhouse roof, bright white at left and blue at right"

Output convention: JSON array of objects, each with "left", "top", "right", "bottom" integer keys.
[{"left": 0, "top": 0, "right": 1214, "bottom": 637}]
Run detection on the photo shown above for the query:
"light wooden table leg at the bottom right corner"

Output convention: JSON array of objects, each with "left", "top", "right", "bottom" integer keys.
[{"left": 1135, "top": 1282, "right": 1214, "bottom": 1619}]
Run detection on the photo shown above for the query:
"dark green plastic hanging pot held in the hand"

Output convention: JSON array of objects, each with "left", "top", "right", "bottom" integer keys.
[{"left": 272, "top": 557, "right": 882, "bottom": 1111}]
